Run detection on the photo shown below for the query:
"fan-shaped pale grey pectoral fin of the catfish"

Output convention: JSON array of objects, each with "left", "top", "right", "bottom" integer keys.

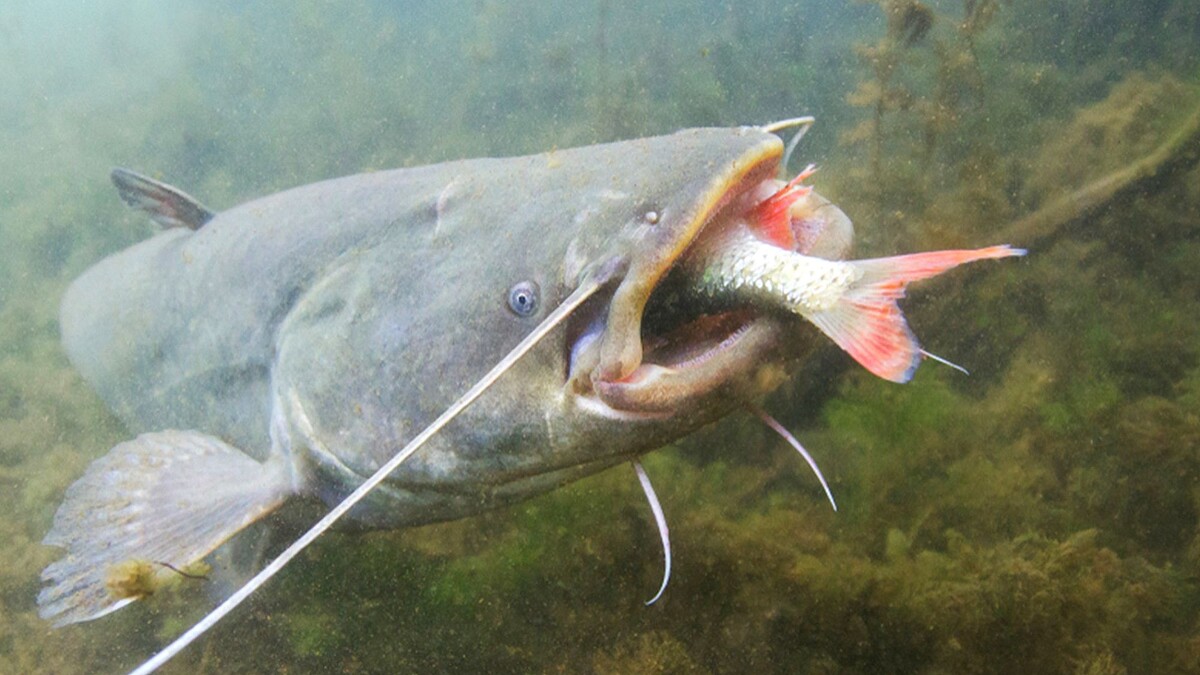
[{"left": 37, "top": 431, "right": 293, "bottom": 626}]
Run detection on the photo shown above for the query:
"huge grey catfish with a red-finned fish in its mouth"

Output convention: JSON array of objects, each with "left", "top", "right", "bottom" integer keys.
[{"left": 38, "top": 120, "right": 1027, "bottom": 658}]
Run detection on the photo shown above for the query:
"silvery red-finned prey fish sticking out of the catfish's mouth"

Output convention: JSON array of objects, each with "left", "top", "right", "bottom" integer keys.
[{"left": 676, "top": 166, "right": 1025, "bottom": 382}]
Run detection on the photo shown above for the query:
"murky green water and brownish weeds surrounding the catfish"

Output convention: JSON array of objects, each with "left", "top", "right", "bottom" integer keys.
[{"left": 0, "top": 0, "right": 1200, "bottom": 675}]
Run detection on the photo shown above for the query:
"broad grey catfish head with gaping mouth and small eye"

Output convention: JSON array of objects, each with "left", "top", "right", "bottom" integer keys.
[{"left": 266, "top": 129, "right": 850, "bottom": 526}]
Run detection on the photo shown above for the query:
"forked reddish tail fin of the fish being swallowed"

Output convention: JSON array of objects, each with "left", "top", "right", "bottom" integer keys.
[{"left": 806, "top": 245, "right": 1025, "bottom": 382}]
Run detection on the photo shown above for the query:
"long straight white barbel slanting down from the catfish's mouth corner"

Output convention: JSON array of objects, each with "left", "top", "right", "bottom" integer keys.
[{"left": 130, "top": 261, "right": 619, "bottom": 675}]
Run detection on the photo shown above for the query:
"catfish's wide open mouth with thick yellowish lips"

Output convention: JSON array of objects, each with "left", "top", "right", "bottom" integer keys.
[{"left": 569, "top": 121, "right": 853, "bottom": 416}]
